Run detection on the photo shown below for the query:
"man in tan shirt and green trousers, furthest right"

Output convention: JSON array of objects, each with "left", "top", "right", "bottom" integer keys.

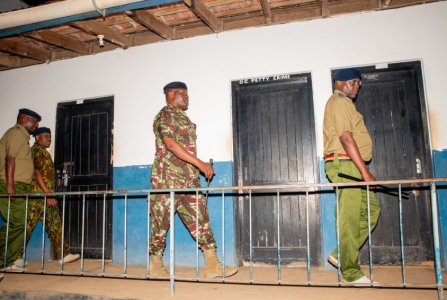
[{"left": 323, "top": 68, "right": 380, "bottom": 284}]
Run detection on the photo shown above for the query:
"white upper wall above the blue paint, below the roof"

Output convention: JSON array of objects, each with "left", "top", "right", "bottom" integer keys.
[{"left": 0, "top": 2, "right": 447, "bottom": 166}]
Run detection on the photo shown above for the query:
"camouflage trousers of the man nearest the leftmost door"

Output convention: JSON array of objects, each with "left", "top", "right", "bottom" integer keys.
[{"left": 17, "top": 199, "right": 70, "bottom": 260}]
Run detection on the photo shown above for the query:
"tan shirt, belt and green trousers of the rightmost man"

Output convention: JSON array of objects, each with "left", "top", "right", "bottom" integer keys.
[{"left": 323, "top": 90, "right": 380, "bottom": 282}]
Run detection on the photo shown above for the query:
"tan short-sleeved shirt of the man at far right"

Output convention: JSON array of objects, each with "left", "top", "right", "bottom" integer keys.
[{"left": 323, "top": 90, "right": 372, "bottom": 161}]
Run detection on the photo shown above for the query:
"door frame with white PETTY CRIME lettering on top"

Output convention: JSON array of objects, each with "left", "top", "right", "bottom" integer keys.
[{"left": 230, "top": 71, "right": 323, "bottom": 267}]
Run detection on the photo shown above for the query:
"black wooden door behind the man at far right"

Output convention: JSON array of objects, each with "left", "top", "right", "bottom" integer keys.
[{"left": 333, "top": 62, "right": 433, "bottom": 264}]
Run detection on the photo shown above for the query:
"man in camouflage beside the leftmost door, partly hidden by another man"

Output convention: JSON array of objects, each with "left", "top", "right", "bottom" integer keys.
[{"left": 14, "top": 127, "right": 80, "bottom": 266}]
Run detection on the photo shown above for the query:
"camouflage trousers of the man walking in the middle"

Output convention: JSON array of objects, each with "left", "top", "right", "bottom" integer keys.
[{"left": 149, "top": 193, "right": 217, "bottom": 255}]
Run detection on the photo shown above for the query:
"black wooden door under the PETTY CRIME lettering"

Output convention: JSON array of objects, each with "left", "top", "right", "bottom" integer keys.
[{"left": 233, "top": 74, "right": 321, "bottom": 265}]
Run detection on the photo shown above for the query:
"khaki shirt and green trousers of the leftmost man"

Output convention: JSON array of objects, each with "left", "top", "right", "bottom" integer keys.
[{"left": 0, "top": 124, "right": 34, "bottom": 267}]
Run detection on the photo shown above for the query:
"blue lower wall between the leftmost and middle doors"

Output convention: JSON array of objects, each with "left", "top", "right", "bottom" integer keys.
[{"left": 113, "top": 162, "right": 236, "bottom": 267}]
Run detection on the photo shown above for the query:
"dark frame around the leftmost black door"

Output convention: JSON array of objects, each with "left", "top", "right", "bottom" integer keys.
[{"left": 54, "top": 95, "right": 115, "bottom": 259}]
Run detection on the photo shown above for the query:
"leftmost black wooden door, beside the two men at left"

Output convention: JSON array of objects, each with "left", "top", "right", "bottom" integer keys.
[{"left": 56, "top": 97, "right": 114, "bottom": 259}]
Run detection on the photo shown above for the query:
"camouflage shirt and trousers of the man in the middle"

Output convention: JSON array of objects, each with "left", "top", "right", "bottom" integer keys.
[{"left": 149, "top": 104, "right": 216, "bottom": 255}]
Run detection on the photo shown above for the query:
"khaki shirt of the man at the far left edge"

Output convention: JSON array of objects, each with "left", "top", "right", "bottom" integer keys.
[{"left": 0, "top": 124, "right": 34, "bottom": 184}]
